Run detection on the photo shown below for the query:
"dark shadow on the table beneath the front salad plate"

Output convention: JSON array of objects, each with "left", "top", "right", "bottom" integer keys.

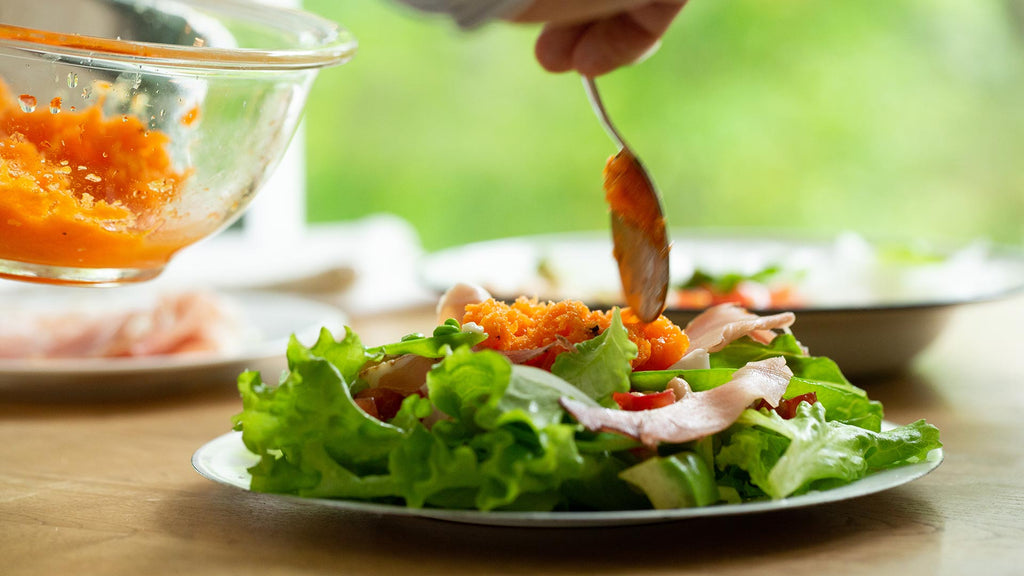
[{"left": 154, "top": 486, "right": 943, "bottom": 574}]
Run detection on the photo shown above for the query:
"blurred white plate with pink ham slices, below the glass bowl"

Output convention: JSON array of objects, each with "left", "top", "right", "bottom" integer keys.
[{"left": 0, "top": 286, "right": 346, "bottom": 402}]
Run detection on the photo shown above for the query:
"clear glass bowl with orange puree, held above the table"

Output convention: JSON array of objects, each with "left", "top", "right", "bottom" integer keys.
[{"left": 0, "top": 0, "right": 356, "bottom": 285}]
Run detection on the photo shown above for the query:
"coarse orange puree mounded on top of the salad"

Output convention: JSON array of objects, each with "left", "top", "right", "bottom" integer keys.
[{"left": 462, "top": 296, "right": 690, "bottom": 370}]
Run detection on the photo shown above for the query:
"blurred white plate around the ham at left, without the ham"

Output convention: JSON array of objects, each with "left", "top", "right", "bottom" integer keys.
[{"left": 0, "top": 289, "right": 345, "bottom": 401}]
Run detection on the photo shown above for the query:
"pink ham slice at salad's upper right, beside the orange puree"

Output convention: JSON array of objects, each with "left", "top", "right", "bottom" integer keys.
[{"left": 684, "top": 304, "right": 797, "bottom": 353}]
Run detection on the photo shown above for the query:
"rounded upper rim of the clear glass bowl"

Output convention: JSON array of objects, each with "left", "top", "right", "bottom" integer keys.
[{"left": 0, "top": 0, "right": 358, "bottom": 72}]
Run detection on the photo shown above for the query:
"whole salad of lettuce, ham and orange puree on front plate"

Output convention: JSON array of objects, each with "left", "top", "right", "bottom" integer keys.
[{"left": 233, "top": 285, "right": 941, "bottom": 512}]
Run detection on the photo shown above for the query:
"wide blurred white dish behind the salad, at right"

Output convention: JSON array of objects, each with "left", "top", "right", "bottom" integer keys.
[{"left": 420, "top": 230, "right": 1024, "bottom": 376}]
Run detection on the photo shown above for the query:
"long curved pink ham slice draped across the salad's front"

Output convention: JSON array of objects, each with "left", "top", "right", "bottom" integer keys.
[{"left": 559, "top": 358, "right": 793, "bottom": 448}]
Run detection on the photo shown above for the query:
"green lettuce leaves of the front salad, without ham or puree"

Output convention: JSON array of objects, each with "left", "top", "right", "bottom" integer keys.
[{"left": 233, "top": 311, "right": 941, "bottom": 510}]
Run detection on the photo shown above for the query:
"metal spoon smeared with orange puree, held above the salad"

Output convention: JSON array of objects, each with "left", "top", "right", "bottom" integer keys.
[{"left": 583, "top": 76, "right": 669, "bottom": 322}]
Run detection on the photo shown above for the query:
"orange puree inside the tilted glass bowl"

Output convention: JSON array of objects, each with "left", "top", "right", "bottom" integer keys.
[{"left": 0, "top": 82, "right": 195, "bottom": 269}]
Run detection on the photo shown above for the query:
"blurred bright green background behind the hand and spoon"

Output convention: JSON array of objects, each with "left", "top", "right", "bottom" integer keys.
[{"left": 303, "top": 0, "right": 1024, "bottom": 250}]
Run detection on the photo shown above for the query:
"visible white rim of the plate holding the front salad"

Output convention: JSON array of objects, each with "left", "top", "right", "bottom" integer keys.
[{"left": 191, "top": 422, "right": 943, "bottom": 528}]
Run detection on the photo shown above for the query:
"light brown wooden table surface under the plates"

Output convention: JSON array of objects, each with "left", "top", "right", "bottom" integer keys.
[{"left": 0, "top": 298, "right": 1024, "bottom": 576}]
